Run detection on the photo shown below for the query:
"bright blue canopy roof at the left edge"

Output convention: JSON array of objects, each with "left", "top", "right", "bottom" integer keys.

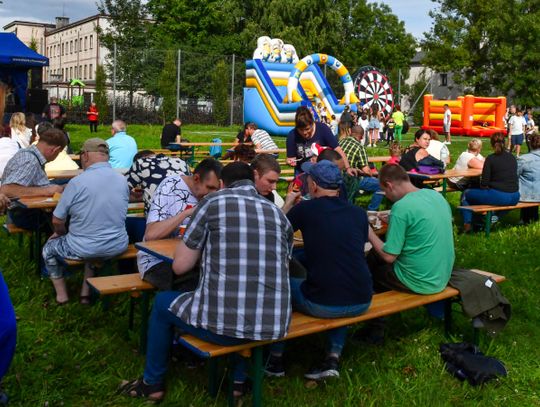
[{"left": 0, "top": 33, "right": 49, "bottom": 68}]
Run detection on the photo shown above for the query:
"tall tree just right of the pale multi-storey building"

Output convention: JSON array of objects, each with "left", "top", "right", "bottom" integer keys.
[{"left": 97, "top": 0, "right": 151, "bottom": 107}]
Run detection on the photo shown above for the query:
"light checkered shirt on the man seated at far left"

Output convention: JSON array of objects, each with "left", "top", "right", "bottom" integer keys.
[{"left": 2, "top": 146, "right": 49, "bottom": 187}]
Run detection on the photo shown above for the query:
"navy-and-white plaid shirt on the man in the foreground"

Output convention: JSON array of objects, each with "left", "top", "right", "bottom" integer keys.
[{"left": 170, "top": 180, "right": 293, "bottom": 340}]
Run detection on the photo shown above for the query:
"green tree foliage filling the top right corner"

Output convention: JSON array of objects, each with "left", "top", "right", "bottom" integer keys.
[{"left": 422, "top": 0, "right": 540, "bottom": 105}]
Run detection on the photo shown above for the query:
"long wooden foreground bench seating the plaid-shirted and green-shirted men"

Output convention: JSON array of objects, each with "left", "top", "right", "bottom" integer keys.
[{"left": 175, "top": 270, "right": 505, "bottom": 406}]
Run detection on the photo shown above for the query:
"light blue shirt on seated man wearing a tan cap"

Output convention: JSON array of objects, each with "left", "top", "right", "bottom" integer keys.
[{"left": 53, "top": 162, "right": 129, "bottom": 258}]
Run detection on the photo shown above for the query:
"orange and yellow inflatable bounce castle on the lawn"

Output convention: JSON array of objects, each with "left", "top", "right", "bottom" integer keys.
[{"left": 422, "top": 95, "right": 506, "bottom": 137}]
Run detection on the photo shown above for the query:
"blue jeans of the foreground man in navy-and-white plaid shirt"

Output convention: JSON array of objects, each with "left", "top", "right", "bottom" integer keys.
[{"left": 143, "top": 291, "right": 250, "bottom": 384}]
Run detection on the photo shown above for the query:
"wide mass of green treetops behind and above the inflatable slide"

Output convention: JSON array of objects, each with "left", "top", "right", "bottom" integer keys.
[{"left": 147, "top": 0, "right": 416, "bottom": 95}]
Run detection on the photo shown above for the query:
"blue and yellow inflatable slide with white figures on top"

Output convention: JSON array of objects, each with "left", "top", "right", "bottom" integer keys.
[{"left": 244, "top": 37, "right": 358, "bottom": 136}]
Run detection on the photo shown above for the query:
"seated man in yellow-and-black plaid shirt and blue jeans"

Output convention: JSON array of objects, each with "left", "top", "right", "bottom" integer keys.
[{"left": 339, "top": 126, "right": 384, "bottom": 211}]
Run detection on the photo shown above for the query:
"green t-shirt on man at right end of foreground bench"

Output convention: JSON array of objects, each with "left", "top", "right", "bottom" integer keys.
[{"left": 383, "top": 189, "right": 455, "bottom": 294}]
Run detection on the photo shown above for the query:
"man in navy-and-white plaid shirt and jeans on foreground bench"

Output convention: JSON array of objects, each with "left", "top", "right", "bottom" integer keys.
[{"left": 123, "top": 162, "right": 293, "bottom": 400}]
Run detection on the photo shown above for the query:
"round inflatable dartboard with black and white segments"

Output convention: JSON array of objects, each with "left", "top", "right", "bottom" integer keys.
[{"left": 354, "top": 66, "right": 394, "bottom": 115}]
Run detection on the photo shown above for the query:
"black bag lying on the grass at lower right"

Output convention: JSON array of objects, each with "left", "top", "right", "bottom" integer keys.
[{"left": 439, "top": 342, "right": 507, "bottom": 386}]
